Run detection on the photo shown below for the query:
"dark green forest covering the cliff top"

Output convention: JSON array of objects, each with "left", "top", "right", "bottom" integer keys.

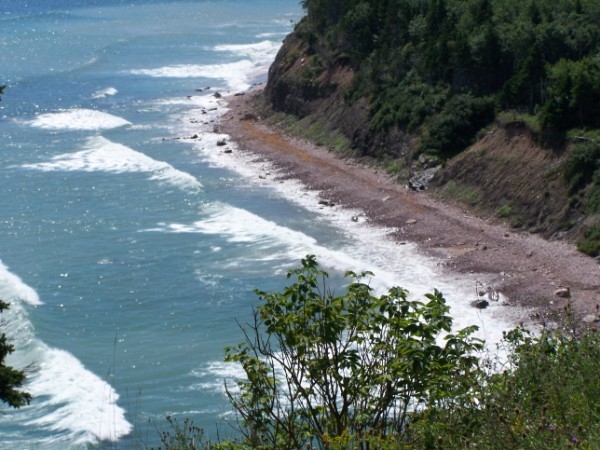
[{"left": 302, "top": 0, "right": 600, "bottom": 153}]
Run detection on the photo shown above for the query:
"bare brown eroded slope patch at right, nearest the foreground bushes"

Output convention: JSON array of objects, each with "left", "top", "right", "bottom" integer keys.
[{"left": 432, "top": 124, "right": 581, "bottom": 239}]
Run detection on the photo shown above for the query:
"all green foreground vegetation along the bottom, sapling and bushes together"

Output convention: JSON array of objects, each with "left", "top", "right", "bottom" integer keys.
[{"left": 154, "top": 256, "right": 600, "bottom": 450}]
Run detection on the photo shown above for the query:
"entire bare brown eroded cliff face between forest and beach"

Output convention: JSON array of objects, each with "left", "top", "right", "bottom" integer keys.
[{"left": 265, "top": 28, "right": 583, "bottom": 243}]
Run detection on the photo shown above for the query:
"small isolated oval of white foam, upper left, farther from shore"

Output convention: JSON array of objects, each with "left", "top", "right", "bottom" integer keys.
[{"left": 29, "top": 109, "right": 131, "bottom": 131}]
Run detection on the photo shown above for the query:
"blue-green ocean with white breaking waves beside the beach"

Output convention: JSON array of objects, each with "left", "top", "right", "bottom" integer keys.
[{"left": 0, "top": 0, "right": 510, "bottom": 450}]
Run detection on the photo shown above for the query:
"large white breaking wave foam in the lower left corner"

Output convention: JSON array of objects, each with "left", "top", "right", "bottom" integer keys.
[{"left": 0, "top": 262, "right": 132, "bottom": 449}]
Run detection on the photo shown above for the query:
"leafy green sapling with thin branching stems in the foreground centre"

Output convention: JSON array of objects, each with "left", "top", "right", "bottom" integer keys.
[{"left": 226, "top": 256, "right": 482, "bottom": 449}]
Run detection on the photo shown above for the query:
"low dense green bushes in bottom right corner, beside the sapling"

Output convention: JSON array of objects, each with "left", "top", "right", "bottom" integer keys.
[{"left": 413, "top": 318, "right": 600, "bottom": 449}]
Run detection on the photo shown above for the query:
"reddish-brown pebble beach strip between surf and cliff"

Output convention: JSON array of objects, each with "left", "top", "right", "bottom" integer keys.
[{"left": 219, "top": 90, "right": 600, "bottom": 326}]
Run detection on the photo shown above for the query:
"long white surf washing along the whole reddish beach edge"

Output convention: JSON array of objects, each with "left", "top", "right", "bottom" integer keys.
[{"left": 155, "top": 89, "right": 526, "bottom": 408}]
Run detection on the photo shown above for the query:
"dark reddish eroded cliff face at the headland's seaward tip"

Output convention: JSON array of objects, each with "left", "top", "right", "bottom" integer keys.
[{"left": 265, "top": 29, "right": 411, "bottom": 157}]
